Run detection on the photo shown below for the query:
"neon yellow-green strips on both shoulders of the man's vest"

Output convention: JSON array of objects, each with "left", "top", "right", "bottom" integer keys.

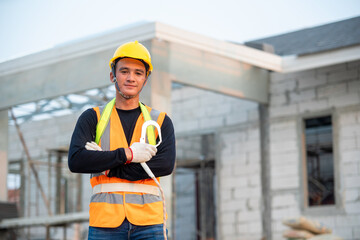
[{"left": 95, "top": 98, "right": 156, "bottom": 145}]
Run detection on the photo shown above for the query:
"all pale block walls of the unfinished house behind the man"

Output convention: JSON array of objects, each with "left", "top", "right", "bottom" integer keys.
[{"left": 9, "top": 61, "right": 360, "bottom": 239}]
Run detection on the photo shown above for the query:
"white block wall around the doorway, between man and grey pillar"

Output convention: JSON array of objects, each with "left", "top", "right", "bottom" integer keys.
[{"left": 172, "top": 87, "right": 262, "bottom": 240}]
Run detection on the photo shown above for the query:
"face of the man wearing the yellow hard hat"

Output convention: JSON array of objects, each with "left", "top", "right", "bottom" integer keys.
[{"left": 111, "top": 58, "right": 147, "bottom": 97}]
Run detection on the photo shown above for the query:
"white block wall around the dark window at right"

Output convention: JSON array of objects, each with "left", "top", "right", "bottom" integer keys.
[{"left": 270, "top": 61, "right": 360, "bottom": 240}]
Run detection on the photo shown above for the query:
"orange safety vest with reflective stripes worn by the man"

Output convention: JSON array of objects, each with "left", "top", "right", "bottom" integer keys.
[{"left": 89, "top": 102, "right": 165, "bottom": 228}]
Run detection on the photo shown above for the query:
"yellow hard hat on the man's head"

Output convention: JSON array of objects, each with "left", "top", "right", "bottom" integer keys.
[{"left": 109, "top": 41, "right": 153, "bottom": 72}]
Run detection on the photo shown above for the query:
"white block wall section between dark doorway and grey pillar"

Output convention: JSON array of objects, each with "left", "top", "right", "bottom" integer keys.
[{"left": 217, "top": 125, "right": 262, "bottom": 239}]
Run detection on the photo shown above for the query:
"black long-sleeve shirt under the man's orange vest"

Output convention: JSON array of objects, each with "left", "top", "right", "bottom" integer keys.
[{"left": 68, "top": 107, "right": 175, "bottom": 181}]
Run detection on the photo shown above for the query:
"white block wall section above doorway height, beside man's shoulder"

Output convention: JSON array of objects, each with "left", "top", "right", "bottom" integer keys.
[{"left": 171, "top": 87, "right": 258, "bottom": 133}]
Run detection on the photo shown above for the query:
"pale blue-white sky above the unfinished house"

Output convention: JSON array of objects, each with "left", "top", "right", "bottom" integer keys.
[{"left": 0, "top": 0, "right": 360, "bottom": 62}]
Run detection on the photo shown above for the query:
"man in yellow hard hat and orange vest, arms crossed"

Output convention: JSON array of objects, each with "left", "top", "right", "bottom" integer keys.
[{"left": 68, "top": 41, "right": 175, "bottom": 239}]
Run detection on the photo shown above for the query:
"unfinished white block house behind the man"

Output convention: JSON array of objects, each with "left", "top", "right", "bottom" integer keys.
[{"left": 0, "top": 17, "right": 360, "bottom": 240}]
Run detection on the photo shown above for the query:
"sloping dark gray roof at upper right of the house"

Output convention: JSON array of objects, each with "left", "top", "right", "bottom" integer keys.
[{"left": 245, "top": 16, "right": 360, "bottom": 56}]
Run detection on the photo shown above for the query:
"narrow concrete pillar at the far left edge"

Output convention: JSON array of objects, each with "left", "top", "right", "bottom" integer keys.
[{"left": 0, "top": 109, "right": 9, "bottom": 202}]
